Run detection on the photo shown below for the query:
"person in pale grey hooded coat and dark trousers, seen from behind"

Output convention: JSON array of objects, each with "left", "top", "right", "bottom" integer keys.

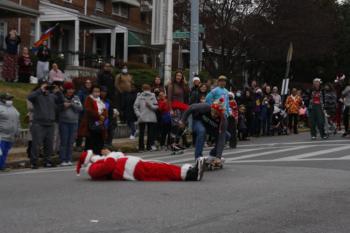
[{"left": 134, "top": 84, "right": 158, "bottom": 151}]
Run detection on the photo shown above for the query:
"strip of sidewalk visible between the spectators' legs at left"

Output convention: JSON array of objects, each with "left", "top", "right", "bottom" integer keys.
[{"left": 6, "top": 138, "right": 138, "bottom": 168}]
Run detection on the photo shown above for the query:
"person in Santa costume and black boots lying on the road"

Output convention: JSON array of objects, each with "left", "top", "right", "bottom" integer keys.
[{"left": 76, "top": 149, "right": 204, "bottom": 181}]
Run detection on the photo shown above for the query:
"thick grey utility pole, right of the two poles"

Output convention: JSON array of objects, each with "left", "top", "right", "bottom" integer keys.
[{"left": 189, "top": 0, "right": 199, "bottom": 87}]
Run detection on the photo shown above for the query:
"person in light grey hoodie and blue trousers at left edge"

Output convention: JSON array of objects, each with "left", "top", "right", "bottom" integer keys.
[{"left": 0, "top": 93, "right": 20, "bottom": 171}]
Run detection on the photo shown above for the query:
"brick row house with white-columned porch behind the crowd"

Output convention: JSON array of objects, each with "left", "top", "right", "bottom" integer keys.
[{"left": 0, "top": 0, "right": 158, "bottom": 74}]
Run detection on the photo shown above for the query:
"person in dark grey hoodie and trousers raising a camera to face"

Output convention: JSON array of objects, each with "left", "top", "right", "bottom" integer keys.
[{"left": 28, "top": 81, "right": 63, "bottom": 169}]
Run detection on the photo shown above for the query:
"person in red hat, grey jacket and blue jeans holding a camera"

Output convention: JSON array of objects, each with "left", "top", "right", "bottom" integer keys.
[{"left": 59, "top": 82, "right": 83, "bottom": 166}]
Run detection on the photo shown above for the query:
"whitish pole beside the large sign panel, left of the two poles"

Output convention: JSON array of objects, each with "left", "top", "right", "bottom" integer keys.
[{"left": 164, "top": 0, "right": 174, "bottom": 85}]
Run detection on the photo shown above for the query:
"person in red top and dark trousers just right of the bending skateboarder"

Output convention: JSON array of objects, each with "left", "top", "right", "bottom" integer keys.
[{"left": 227, "top": 92, "right": 238, "bottom": 148}]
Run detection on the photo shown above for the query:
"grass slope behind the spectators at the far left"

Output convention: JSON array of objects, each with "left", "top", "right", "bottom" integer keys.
[{"left": 0, "top": 81, "right": 35, "bottom": 128}]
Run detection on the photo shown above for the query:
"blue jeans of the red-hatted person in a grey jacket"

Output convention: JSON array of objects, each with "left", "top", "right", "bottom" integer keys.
[{"left": 59, "top": 122, "right": 78, "bottom": 162}]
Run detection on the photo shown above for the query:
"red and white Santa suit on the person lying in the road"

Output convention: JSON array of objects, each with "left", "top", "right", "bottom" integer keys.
[{"left": 78, "top": 152, "right": 191, "bottom": 181}]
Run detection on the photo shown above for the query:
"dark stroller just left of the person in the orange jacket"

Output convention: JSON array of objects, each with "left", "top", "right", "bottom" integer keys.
[{"left": 271, "top": 106, "right": 288, "bottom": 136}]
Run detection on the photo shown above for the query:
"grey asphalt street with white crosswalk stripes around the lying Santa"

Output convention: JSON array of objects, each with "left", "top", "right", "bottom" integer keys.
[{"left": 0, "top": 133, "right": 350, "bottom": 233}]
